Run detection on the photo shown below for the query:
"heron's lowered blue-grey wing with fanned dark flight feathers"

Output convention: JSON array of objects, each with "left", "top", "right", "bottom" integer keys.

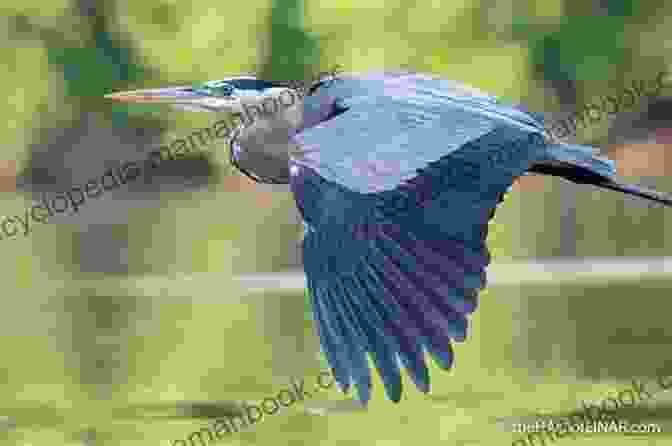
[{"left": 291, "top": 74, "right": 545, "bottom": 402}]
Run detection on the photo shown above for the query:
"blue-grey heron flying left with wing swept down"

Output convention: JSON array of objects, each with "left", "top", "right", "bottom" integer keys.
[{"left": 108, "top": 72, "right": 672, "bottom": 404}]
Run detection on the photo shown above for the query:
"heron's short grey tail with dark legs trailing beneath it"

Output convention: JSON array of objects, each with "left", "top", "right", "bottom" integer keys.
[{"left": 528, "top": 143, "right": 672, "bottom": 206}]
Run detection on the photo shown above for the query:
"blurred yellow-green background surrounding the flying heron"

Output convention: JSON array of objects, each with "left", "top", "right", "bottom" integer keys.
[{"left": 0, "top": 0, "right": 672, "bottom": 446}]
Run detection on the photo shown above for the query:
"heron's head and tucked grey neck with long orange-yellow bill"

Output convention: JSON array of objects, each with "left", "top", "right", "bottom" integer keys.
[{"left": 105, "top": 76, "right": 344, "bottom": 184}]
